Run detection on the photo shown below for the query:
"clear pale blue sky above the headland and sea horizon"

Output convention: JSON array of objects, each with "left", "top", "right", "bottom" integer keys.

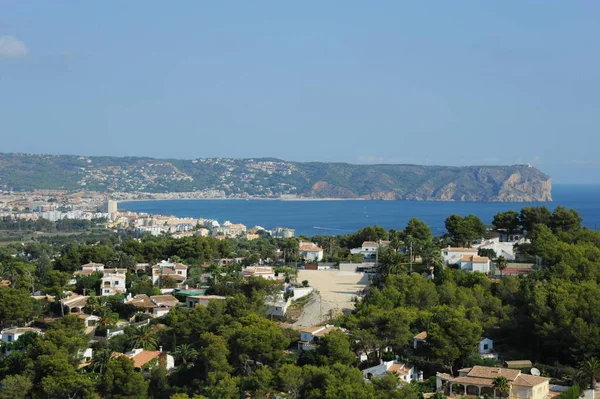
[{"left": 0, "top": 0, "right": 600, "bottom": 183}]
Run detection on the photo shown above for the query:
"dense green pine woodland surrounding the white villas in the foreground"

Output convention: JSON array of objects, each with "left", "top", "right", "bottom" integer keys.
[{"left": 0, "top": 207, "right": 600, "bottom": 399}]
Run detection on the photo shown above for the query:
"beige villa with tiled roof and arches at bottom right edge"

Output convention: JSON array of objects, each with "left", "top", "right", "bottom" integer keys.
[{"left": 436, "top": 366, "right": 550, "bottom": 399}]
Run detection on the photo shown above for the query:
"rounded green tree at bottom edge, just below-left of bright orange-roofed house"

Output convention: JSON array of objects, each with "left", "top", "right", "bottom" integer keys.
[{"left": 99, "top": 356, "right": 148, "bottom": 399}]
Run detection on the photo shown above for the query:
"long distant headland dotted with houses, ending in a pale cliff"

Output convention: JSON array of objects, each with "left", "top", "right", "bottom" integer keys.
[{"left": 0, "top": 154, "right": 552, "bottom": 202}]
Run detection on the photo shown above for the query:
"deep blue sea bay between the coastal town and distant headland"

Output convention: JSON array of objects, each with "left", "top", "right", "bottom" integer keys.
[{"left": 119, "top": 184, "right": 600, "bottom": 236}]
